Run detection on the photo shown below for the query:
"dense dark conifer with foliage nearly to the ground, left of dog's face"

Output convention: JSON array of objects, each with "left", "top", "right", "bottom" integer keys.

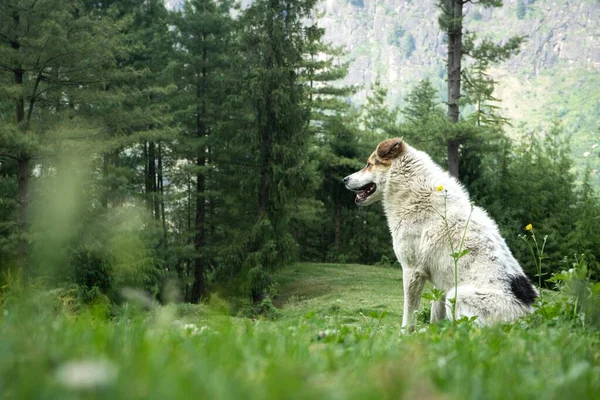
[{"left": 231, "top": 0, "right": 322, "bottom": 301}]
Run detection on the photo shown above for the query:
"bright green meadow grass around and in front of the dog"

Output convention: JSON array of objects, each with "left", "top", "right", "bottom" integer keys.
[{"left": 0, "top": 264, "right": 600, "bottom": 399}]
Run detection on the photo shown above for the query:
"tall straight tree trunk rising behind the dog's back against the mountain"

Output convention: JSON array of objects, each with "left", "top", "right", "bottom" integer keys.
[{"left": 447, "top": 0, "right": 463, "bottom": 179}]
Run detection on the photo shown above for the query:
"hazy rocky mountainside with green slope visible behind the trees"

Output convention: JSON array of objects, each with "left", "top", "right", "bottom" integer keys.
[{"left": 166, "top": 0, "right": 600, "bottom": 175}]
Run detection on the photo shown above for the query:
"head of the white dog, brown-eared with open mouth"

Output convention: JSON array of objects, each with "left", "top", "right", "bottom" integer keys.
[{"left": 344, "top": 138, "right": 406, "bottom": 206}]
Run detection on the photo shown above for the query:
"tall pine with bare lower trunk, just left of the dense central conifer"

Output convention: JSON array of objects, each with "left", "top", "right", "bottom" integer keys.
[{"left": 174, "top": 0, "right": 233, "bottom": 303}]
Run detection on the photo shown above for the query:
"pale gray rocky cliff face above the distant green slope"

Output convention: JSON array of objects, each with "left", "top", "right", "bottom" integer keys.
[{"left": 319, "top": 0, "right": 600, "bottom": 104}]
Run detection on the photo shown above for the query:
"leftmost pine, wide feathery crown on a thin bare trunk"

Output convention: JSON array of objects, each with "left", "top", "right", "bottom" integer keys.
[{"left": 0, "top": 0, "right": 114, "bottom": 276}]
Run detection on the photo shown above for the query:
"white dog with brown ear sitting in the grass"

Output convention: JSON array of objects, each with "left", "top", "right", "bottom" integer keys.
[{"left": 344, "top": 138, "right": 538, "bottom": 330}]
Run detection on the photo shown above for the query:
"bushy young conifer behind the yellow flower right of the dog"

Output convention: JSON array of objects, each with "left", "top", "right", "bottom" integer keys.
[{"left": 501, "top": 122, "right": 576, "bottom": 275}]
